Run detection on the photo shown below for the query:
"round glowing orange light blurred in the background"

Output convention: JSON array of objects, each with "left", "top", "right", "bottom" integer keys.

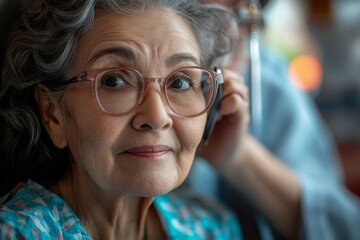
[{"left": 289, "top": 55, "right": 322, "bottom": 91}]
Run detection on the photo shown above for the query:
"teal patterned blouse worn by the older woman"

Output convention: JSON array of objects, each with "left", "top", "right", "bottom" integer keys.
[{"left": 0, "top": 180, "right": 241, "bottom": 240}]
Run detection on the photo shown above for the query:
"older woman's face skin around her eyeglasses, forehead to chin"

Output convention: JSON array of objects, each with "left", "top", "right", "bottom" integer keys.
[{"left": 53, "top": 9, "right": 206, "bottom": 196}]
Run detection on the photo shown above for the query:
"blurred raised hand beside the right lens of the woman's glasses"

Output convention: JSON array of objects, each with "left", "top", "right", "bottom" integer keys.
[{"left": 198, "top": 69, "right": 249, "bottom": 171}]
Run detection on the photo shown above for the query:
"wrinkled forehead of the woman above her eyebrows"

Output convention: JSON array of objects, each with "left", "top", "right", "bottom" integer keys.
[{"left": 73, "top": 9, "right": 200, "bottom": 71}]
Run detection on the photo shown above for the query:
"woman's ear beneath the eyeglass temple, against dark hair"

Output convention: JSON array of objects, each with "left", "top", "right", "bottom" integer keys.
[{"left": 35, "top": 84, "right": 67, "bottom": 148}]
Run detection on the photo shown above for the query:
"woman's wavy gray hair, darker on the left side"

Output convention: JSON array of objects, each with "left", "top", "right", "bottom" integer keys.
[{"left": 0, "top": 0, "right": 235, "bottom": 193}]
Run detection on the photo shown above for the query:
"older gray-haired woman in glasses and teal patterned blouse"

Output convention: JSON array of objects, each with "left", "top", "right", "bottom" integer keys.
[{"left": 0, "top": 0, "right": 247, "bottom": 239}]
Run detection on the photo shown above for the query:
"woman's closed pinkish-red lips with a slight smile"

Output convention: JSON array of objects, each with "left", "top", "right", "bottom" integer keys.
[{"left": 125, "top": 145, "right": 172, "bottom": 159}]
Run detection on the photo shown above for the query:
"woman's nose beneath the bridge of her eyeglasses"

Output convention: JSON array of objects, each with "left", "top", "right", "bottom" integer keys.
[{"left": 132, "top": 84, "right": 173, "bottom": 131}]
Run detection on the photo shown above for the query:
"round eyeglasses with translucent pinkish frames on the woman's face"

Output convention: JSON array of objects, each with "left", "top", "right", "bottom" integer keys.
[{"left": 47, "top": 66, "right": 223, "bottom": 117}]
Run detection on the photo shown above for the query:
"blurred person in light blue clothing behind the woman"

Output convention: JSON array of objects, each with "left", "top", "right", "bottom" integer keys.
[{"left": 186, "top": 0, "right": 360, "bottom": 239}]
